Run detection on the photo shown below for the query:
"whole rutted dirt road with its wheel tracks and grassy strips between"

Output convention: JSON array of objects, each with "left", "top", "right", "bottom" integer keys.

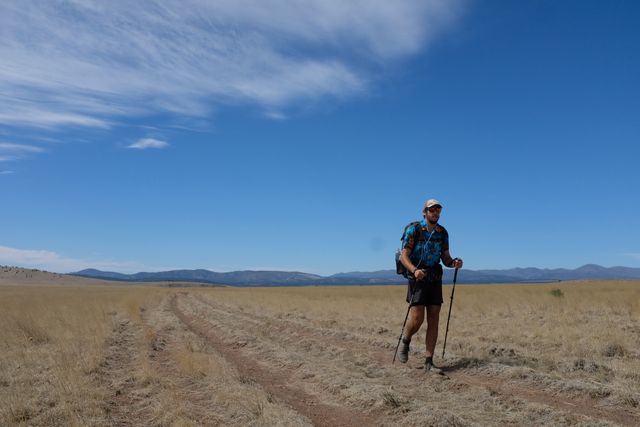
[{"left": 96, "top": 291, "right": 640, "bottom": 426}]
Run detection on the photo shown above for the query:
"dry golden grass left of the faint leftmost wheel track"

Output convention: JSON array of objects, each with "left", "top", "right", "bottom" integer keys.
[{"left": 0, "top": 286, "right": 165, "bottom": 425}]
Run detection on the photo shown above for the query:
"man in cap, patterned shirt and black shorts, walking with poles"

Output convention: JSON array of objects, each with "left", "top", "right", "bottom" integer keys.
[{"left": 398, "top": 199, "right": 462, "bottom": 373}]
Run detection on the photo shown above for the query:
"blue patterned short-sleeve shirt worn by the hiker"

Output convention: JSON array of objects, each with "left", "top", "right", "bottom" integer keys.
[{"left": 402, "top": 219, "right": 449, "bottom": 268}]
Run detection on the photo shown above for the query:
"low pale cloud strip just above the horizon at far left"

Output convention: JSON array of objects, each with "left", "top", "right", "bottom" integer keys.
[{"left": 0, "top": 246, "right": 159, "bottom": 273}]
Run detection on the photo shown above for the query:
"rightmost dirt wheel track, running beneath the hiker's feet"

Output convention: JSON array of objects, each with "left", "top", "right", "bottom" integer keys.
[{"left": 196, "top": 296, "right": 640, "bottom": 426}]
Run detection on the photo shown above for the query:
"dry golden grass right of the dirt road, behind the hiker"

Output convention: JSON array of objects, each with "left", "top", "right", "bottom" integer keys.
[{"left": 189, "top": 281, "right": 640, "bottom": 422}]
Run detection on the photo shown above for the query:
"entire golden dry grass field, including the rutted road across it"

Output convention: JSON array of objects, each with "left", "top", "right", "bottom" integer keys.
[{"left": 0, "top": 270, "right": 640, "bottom": 426}]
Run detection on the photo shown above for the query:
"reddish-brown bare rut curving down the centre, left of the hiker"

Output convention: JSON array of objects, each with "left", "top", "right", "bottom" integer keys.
[{"left": 170, "top": 296, "right": 376, "bottom": 426}]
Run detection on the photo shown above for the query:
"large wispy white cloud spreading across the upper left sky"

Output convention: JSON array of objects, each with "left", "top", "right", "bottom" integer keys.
[{"left": 0, "top": 0, "right": 463, "bottom": 128}]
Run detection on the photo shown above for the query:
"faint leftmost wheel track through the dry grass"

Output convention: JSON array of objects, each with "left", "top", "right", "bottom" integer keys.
[{"left": 94, "top": 313, "right": 149, "bottom": 427}]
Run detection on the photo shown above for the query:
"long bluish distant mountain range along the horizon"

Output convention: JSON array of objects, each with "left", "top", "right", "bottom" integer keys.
[{"left": 70, "top": 264, "right": 640, "bottom": 286}]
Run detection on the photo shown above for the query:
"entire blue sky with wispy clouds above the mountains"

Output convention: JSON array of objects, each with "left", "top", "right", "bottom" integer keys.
[{"left": 0, "top": 0, "right": 640, "bottom": 275}]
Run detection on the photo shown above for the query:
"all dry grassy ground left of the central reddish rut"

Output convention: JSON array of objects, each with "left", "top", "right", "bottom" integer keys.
[{"left": 0, "top": 285, "right": 312, "bottom": 426}]
